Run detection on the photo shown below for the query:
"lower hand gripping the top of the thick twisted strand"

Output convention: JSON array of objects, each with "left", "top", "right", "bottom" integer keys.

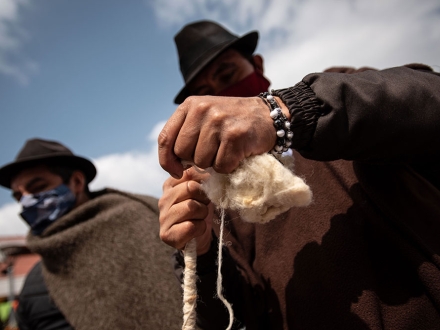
[{"left": 159, "top": 168, "right": 214, "bottom": 255}]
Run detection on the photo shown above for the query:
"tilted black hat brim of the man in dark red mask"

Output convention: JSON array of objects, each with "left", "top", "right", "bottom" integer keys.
[{"left": 174, "top": 31, "right": 258, "bottom": 104}]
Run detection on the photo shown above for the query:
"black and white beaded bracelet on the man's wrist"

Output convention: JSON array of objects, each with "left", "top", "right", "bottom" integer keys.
[{"left": 258, "top": 92, "right": 293, "bottom": 155}]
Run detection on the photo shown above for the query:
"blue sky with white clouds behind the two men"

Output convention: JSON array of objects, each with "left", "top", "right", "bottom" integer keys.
[{"left": 0, "top": 0, "right": 440, "bottom": 235}]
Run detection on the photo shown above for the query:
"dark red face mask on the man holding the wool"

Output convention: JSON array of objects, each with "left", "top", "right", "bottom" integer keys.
[{"left": 218, "top": 70, "right": 270, "bottom": 97}]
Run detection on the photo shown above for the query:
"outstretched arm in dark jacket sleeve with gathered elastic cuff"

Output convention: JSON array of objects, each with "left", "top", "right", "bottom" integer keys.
[{"left": 275, "top": 67, "right": 440, "bottom": 160}]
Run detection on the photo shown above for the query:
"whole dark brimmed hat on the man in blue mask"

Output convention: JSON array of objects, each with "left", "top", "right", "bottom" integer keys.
[{"left": 0, "top": 139, "right": 96, "bottom": 189}]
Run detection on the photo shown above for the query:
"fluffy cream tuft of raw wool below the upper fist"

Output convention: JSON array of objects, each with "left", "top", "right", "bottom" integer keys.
[{"left": 202, "top": 154, "right": 312, "bottom": 224}]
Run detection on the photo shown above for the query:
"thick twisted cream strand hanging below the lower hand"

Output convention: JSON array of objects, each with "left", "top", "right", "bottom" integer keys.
[{"left": 182, "top": 238, "right": 197, "bottom": 330}]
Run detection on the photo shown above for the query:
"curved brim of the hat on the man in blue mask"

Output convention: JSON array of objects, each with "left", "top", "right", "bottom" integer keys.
[{"left": 0, "top": 154, "right": 96, "bottom": 189}]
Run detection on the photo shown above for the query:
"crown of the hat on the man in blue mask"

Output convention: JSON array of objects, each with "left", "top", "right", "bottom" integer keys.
[{"left": 15, "top": 139, "right": 73, "bottom": 161}]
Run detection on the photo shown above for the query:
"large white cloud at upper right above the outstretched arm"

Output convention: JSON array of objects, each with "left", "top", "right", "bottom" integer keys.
[{"left": 261, "top": 0, "right": 440, "bottom": 88}]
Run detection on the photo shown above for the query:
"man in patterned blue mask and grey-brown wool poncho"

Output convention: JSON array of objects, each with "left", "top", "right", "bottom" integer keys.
[{"left": 0, "top": 139, "right": 181, "bottom": 330}]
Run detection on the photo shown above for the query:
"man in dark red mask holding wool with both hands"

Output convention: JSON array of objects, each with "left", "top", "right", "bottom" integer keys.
[{"left": 159, "top": 21, "right": 440, "bottom": 330}]
